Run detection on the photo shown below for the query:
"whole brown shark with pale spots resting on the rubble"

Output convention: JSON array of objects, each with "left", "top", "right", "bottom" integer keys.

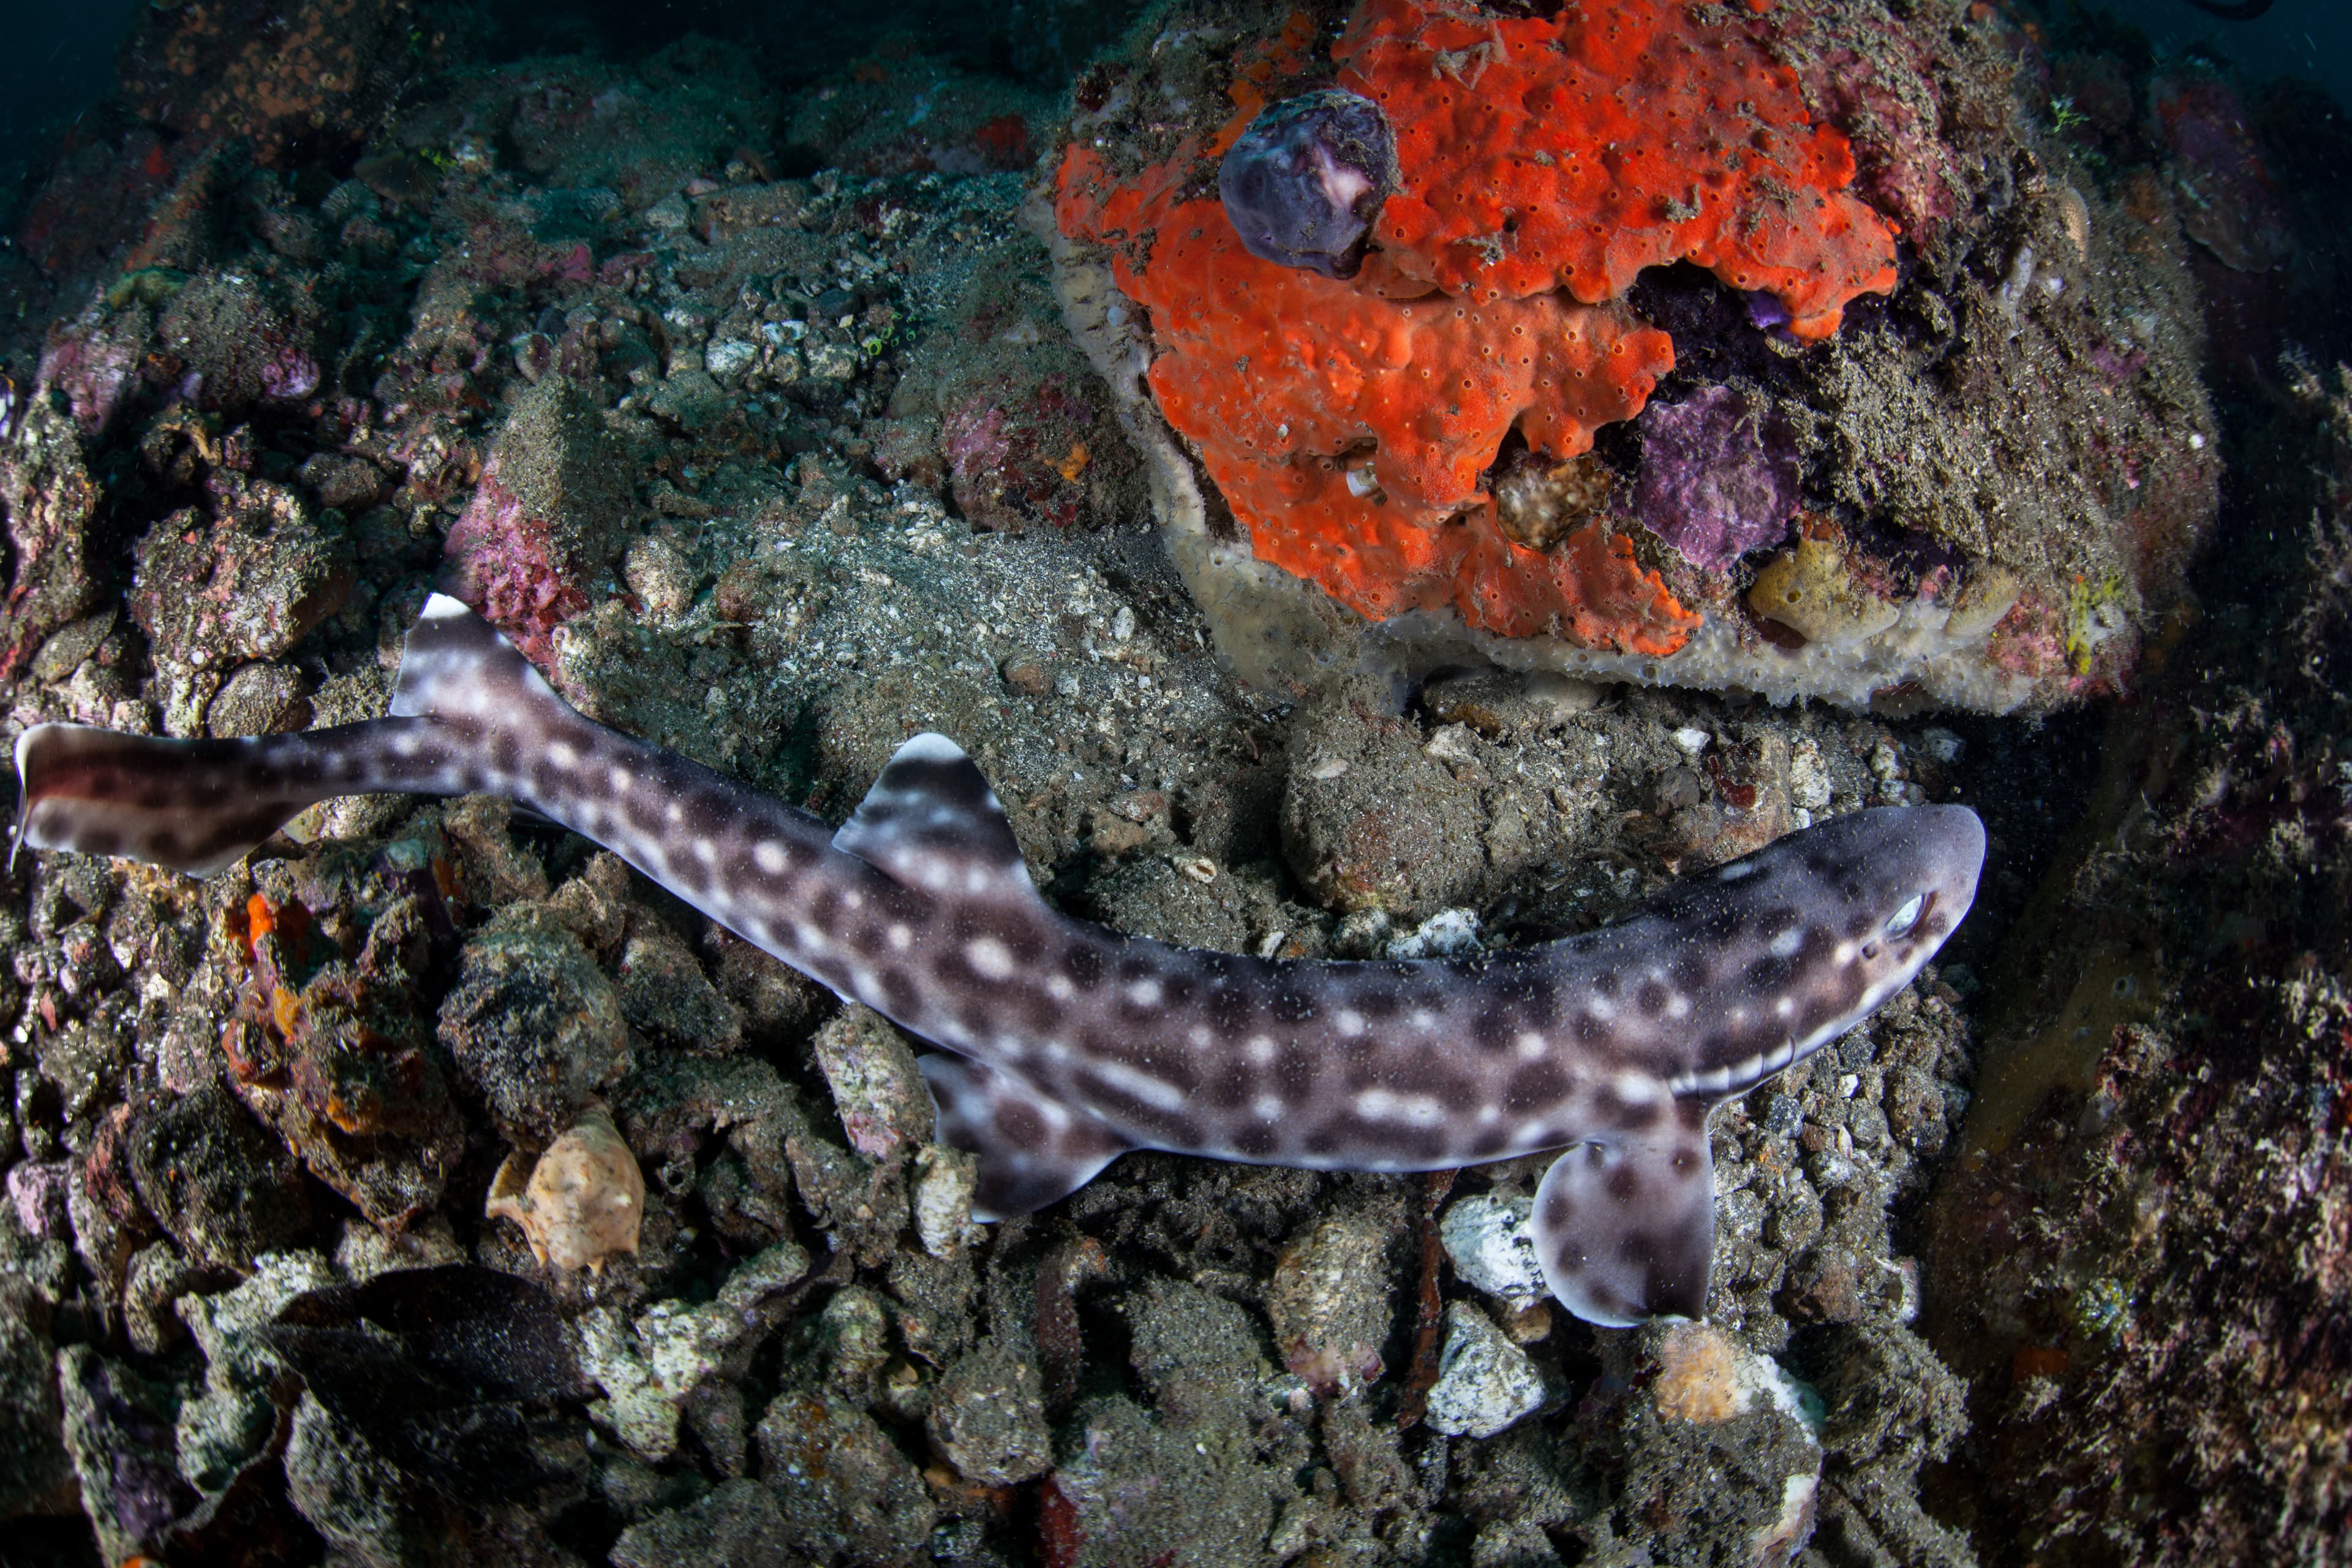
[{"left": 17, "top": 595, "right": 1985, "bottom": 1326}]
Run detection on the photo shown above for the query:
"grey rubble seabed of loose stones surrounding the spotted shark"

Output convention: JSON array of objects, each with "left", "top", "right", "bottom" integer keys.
[{"left": 0, "top": 0, "right": 2352, "bottom": 1568}]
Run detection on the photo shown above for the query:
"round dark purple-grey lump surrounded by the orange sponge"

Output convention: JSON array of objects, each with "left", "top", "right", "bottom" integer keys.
[{"left": 1216, "top": 87, "right": 1397, "bottom": 277}]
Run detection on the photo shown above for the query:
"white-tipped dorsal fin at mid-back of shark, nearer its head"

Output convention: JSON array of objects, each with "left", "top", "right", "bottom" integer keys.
[{"left": 832, "top": 733, "right": 1037, "bottom": 898}]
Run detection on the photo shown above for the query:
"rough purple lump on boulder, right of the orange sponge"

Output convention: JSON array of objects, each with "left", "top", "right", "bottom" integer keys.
[{"left": 1635, "top": 385, "right": 1800, "bottom": 571}]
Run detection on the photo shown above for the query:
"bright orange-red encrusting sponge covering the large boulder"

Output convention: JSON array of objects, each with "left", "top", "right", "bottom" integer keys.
[{"left": 1056, "top": 0, "right": 1896, "bottom": 654}]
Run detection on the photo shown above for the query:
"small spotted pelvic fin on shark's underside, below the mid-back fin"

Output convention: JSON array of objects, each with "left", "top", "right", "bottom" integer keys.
[{"left": 918, "top": 1055, "right": 1136, "bottom": 1220}]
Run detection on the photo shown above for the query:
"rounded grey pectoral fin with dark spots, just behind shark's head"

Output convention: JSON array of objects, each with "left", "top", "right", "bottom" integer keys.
[{"left": 1536, "top": 1100, "right": 1714, "bottom": 1329}]
